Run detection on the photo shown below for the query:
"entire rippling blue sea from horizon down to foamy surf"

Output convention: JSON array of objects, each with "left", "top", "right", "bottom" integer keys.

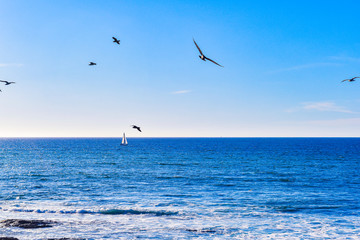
[{"left": 0, "top": 138, "right": 360, "bottom": 239}]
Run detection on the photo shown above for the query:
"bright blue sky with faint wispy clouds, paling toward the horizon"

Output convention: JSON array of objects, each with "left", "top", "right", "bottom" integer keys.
[{"left": 0, "top": 0, "right": 360, "bottom": 137}]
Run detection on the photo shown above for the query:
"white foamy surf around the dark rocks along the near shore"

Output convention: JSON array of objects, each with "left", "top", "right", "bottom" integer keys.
[{"left": 0, "top": 202, "right": 360, "bottom": 239}]
